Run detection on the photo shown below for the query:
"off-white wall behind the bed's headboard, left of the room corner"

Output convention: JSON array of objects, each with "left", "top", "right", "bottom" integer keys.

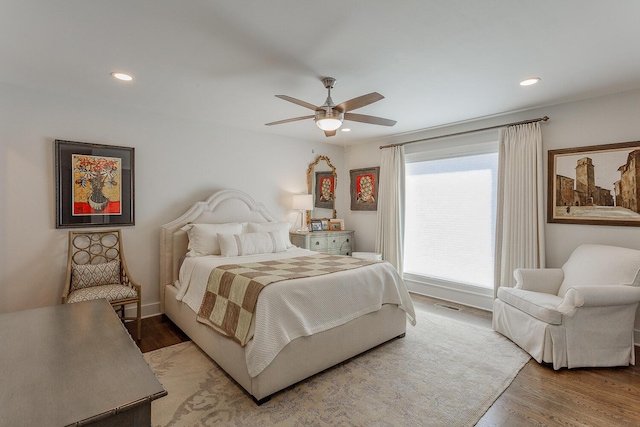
[{"left": 0, "top": 85, "right": 348, "bottom": 315}]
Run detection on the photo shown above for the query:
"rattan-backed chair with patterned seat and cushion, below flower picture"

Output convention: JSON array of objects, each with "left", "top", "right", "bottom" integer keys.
[{"left": 62, "top": 230, "right": 142, "bottom": 340}]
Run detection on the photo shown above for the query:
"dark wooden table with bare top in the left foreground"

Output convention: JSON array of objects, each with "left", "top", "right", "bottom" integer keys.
[{"left": 0, "top": 299, "right": 167, "bottom": 426}]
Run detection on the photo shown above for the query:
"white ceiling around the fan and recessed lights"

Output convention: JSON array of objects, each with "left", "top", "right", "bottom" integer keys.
[{"left": 0, "top": 0, "right": 640, "bottom": 144}]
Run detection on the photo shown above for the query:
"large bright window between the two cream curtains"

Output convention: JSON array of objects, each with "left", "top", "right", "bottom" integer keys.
[{"left": 404, "top": 147, "right": 498, "bottom": 288}]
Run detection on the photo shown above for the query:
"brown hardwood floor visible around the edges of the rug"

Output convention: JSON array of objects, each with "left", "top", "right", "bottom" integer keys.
[{"left": 127, "top": 294, "right": 640, "bottom": 427}]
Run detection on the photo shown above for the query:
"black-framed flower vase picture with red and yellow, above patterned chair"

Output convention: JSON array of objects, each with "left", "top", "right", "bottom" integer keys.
[{"left": 54, "top": 140, "right": 135, "bottom": 228}]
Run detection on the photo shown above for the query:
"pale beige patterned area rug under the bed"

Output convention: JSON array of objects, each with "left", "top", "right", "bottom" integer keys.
[{"left": 144, "top": 312, "right": 529, "bottom": 427}]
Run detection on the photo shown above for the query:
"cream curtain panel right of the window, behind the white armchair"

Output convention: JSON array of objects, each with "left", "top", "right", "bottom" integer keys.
[{"left": 494, "top": 122, "right": 545, "bottom": 292}]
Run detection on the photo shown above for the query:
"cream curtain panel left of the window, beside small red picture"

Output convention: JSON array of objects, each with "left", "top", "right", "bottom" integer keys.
[{"left": 376, "top": 146, "right": 405, "bottom": 276}]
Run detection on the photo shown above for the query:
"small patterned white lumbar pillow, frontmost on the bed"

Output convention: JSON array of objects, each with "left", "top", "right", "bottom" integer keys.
[{"left": 218, "top": 231, "right": 287, "bottom": 256}]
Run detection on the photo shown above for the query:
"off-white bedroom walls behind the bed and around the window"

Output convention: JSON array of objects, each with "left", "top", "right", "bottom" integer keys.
[{"left": 0, "top": 79, "right": 640, "bottom": 341}]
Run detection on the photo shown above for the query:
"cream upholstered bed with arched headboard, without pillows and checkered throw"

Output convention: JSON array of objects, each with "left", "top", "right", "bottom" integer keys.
[{"left": 160, "top": 190, "right": 415, "bottom": 404}]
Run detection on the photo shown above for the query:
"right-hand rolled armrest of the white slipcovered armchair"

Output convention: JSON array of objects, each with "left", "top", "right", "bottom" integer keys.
[{"left": 558, "top": 285, "right": 640, "bottom": 316}]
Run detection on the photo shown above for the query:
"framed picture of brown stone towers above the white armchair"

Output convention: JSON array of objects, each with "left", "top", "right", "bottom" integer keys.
[{"left": 547, "top": 141, "right": 640, "bottom": 226}]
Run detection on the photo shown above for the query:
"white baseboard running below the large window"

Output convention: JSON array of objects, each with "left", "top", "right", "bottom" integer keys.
[{"left": 403, "top": 274, "right": 493, "bottom": 311}]
